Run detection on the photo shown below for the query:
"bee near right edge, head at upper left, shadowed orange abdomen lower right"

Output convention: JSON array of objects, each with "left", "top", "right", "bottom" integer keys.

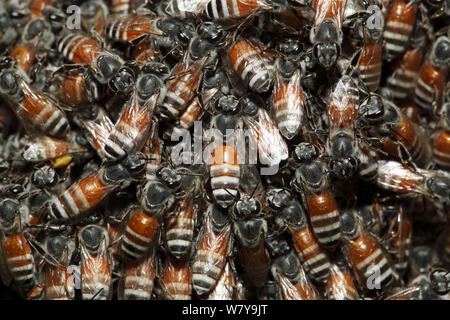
[{"left": 360, "top": 95, "right": 432, "bottom": 167}]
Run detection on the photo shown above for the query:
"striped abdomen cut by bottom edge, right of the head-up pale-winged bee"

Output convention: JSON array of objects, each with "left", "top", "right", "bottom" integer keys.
[{"left": 118, "top": 254, "right": 156, "bottom": 300}]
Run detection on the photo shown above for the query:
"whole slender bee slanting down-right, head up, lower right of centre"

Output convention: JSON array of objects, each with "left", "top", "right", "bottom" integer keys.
[{"left": 266, "top": 189, "right": 330, "bottom": 282}]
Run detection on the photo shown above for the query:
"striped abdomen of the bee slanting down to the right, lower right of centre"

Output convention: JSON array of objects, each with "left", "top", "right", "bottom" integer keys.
[{"left": 291, "top": 227, "right": 330, "bottom": 281}]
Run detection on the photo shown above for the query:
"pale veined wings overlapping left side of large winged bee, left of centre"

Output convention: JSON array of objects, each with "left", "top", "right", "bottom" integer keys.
[{"left": 80, "top": 112, "right": 114, "bottom": 159}]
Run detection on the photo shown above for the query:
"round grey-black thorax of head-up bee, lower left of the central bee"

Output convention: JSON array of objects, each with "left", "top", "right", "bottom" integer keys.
[{"left": 141, "top": 182, "right": 174, "bottom": 212}]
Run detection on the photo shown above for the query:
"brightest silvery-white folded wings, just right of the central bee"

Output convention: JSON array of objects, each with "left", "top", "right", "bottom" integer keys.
[{"left": 244, "top": 108, "right": 289, "bottom": 165}]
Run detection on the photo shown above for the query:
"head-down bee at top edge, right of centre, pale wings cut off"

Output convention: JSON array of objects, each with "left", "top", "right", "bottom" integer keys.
[{"left": 310, "top": 0, "right": 347, "bottom": 69}]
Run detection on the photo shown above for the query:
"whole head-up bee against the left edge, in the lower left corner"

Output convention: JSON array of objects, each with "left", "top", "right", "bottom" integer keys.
[{"left": 0, "top": 198, "right": 38, "bottom": 296}]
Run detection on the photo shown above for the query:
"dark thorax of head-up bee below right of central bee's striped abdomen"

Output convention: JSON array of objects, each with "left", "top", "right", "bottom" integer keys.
[{"left": 234, "top": 219, "right": 265, "bottom": 248}]
